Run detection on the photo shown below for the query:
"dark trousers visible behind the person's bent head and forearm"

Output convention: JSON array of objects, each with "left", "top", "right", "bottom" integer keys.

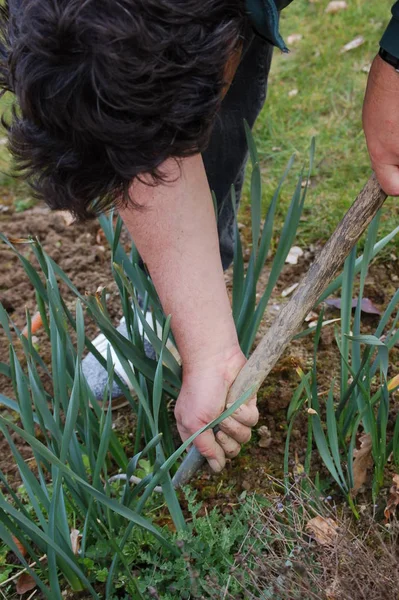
[{"left": 203, "top": 33, "right": 273, "bottom": 269}]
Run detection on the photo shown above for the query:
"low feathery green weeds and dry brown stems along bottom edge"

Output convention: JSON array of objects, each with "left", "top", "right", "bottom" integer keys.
[{"left": 6, "top": 480, "right": 398, "bottom": 600}]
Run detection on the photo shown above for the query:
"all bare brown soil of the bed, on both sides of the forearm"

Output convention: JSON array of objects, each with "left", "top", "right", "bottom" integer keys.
[{"left": 0, "top": 203, "right": 399, "bottom": 511}]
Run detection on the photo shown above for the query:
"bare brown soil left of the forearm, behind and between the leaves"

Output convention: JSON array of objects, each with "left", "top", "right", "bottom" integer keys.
[{"left": 0, "top": 204, "right": 127, "bottom": 482}]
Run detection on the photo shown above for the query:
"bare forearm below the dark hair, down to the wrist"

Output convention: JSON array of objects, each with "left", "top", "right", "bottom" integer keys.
[{"left": 121, "top": 155, "right": 238, "bottom": 373}]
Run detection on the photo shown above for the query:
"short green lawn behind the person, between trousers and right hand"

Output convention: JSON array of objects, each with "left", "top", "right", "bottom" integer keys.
[{"left": 244, "top": 0, "right": 398, "bottom": 245}]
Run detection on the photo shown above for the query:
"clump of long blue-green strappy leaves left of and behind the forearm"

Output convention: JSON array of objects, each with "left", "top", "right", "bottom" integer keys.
[{"left": 0, "top": 126, "right": 314, "bottom": 600}]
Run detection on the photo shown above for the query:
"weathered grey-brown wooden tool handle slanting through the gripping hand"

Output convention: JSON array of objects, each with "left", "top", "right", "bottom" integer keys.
[{"left": 173, "top": 174, "right": 387, "bottom": 487}]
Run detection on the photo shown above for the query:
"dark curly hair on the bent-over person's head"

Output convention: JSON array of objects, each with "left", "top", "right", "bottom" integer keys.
[{"left": 0, "top": 0, "right": 245, "bottom": 220}]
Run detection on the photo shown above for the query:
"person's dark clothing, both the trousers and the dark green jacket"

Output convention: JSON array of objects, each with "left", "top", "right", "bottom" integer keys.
[{"left": 209, "top": 0, "right": 399, "bottom": 269}]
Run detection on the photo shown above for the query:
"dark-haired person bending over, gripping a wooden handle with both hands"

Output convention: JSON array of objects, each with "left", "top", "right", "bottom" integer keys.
[{"left": 0, "top": 0, "right": 399, "bottom": 471}]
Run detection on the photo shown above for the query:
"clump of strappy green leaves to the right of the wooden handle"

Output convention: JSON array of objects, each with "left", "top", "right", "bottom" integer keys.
[{"left": 285, "top": 213, "right": 399, "bottom": 513}]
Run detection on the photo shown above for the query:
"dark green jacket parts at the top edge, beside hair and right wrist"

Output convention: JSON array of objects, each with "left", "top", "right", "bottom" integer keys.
[{"left": 246, "top": 0, "right": 399, "bottom": 58}]
